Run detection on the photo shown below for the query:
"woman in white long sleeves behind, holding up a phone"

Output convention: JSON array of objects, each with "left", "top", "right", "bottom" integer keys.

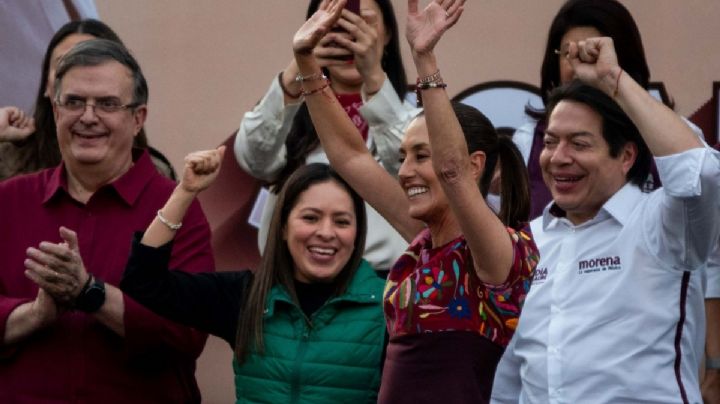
[{"left": 235, "top": 0, "right": 420, "bottom": 270}]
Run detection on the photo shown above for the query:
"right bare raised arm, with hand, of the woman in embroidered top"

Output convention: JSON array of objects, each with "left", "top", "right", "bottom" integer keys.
[{"left": 407, "top": 0, "right": 513, "bottom": 284}]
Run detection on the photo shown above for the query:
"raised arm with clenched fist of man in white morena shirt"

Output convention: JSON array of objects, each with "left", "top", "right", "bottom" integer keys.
[{"left": 567, "top": 37, "right": 720, "bottom": 270}]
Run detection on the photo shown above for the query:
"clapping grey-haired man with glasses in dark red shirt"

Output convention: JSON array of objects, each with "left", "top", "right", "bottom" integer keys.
[{"left": 0, "top": 40, "right": 214, "bottom": 403}]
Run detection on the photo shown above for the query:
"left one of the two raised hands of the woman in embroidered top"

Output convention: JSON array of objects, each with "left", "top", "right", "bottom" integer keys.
[{"left": 293, "top": 0, "right": 346, "bottom": 55}]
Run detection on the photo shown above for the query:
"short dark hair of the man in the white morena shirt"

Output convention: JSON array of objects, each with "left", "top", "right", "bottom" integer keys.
[{"left": 544, "top": 80, "right": 652, "bottom": 188}]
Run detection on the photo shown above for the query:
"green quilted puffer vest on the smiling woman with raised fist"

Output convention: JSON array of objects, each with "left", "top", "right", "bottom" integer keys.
[{"left": 233, "top": 260, "right": 385, "bottom": 404}]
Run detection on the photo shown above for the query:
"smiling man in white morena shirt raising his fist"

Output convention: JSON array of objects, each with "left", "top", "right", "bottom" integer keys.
[{"left": 492, "top": 37, "right": 720, "bottom": 404}]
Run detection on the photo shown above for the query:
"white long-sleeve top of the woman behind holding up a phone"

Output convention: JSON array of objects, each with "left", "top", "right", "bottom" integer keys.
[{"left": 234, "top": 74, "right": 420, "bottom": 269}]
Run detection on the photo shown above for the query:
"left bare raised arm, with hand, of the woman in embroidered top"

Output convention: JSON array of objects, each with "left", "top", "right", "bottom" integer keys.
[{"left": 293, "top": 0, "right": 422, "bottom": 241}]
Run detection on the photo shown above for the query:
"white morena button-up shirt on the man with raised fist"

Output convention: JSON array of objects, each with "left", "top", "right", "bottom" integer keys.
[{"left": 492, "top": 148, "right": 720, "bottom": 404}]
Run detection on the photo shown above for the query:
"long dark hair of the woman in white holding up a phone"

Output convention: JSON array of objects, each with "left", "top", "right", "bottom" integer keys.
[{"left": 272, "top": 0, "right": 407, "bottom": 190}]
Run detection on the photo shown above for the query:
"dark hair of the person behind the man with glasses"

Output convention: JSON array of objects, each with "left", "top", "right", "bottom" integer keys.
[{"left": 4, "top": 19, "right": 147, "bottom": 175}]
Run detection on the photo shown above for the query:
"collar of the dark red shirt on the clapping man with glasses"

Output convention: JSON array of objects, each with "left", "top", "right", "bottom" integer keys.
[{"left": 43, "top": 149, "right": 159, "bottom": 206}]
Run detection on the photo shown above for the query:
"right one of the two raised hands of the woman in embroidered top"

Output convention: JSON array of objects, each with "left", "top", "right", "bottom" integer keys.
[{"left": 405, "top": 0, "right": 465, "bottom": 54}]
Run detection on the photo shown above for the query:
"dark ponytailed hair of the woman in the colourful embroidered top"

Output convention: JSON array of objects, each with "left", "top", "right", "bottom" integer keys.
[{"left": 452, "top": 102, "right": 530, "bottom": 229}]
